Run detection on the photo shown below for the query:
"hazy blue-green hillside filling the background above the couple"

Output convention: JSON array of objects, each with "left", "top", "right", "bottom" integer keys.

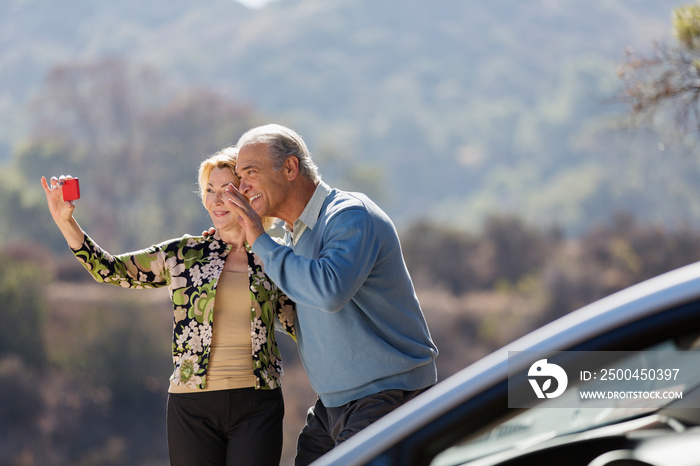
[{"left": 0, "top": 0, "right": 700, "bottom": 240}]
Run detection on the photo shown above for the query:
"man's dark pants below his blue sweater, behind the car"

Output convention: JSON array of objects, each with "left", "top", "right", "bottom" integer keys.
[{"left": 294, "top": 388, "right": 427, "bottom": 466}]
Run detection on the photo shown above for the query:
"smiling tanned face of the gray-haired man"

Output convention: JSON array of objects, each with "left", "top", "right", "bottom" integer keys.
[{"left": 236, "top": 144, "right": 289, "bottom": 219}]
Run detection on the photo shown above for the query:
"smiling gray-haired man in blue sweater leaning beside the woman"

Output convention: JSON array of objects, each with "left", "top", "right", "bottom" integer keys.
[{"left": 221, "top": 124, "right": 438, "bottom": 465}]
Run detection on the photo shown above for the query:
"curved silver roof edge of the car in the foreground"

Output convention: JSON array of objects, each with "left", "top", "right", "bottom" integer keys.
[{"left": 314, "top": 262, "right": 700, "bottom": 466}]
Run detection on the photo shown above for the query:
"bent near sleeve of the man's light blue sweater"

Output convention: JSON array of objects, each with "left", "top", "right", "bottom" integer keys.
[{"left": 253, "top": 209, "right": 379, "bottom": 312}]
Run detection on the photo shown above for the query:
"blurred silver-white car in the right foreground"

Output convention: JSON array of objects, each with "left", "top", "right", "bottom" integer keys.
[{"left": 314, "top": 263, "right": 700, "bottom": 466}]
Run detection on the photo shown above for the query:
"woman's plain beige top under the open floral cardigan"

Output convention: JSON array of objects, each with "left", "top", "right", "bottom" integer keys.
[{"left": 168, "top": 270, "right": 255, "bottom": 393}]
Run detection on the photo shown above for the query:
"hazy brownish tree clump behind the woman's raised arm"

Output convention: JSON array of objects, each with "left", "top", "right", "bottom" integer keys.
[{"left": 11, "top": 59, "right": 257, "bottom": 252}]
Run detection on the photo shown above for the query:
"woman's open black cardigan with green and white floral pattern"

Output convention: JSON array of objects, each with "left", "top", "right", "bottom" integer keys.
[{"left": 73, "top": 232, "right": 295, "bottom": 389}]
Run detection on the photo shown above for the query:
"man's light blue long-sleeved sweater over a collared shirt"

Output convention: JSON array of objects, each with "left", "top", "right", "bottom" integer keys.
[{"left": 253, "top": 184, "right": 438, "bottom": 407}]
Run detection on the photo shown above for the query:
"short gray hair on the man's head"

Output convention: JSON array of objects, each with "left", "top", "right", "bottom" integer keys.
[{"left": 236, "top": 123, "right": 321, "bottom": 183}]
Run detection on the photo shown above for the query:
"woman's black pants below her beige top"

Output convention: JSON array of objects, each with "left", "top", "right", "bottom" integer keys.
[{"left": 167, "top": 388, "right": 284, "bottom": 466}]
